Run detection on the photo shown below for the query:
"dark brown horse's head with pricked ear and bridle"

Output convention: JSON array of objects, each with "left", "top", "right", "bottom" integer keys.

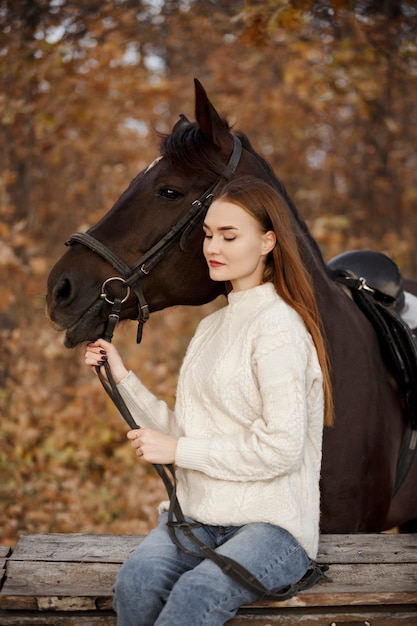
[{"left": 47, "top": 81, "right": 318, "bottom": 347}]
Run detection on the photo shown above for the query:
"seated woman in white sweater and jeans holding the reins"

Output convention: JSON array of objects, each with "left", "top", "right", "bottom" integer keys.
[{"left": 85, "top": 177, "right": 332, "bottom": 626}]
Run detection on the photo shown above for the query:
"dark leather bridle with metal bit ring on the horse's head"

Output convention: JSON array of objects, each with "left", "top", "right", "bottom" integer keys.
[{"left": 65, "top": 136, "right": 242, "bottom": 343}]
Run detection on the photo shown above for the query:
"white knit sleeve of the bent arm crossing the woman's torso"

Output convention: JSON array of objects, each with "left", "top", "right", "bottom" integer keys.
[{"left": 176, "top": 324, "right": 309, "bottom": 481}]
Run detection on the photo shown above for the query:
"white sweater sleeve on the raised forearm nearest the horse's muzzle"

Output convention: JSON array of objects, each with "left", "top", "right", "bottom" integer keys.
[{"left": 117, "top": 372, "right": 178, "bottom": 436}]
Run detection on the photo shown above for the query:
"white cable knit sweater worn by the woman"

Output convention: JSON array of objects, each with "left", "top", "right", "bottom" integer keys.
[{"left": 118, "top": 283, "right": 324, "bottom": 558}]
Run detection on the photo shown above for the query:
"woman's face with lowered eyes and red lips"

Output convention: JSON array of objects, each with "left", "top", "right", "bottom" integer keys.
[{"left": 203, "top": 198, "right": 276, "bottom": 291}]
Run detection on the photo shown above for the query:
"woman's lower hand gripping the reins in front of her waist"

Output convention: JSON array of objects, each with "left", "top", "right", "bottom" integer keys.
[{"left": 127, "top": 428, "right": 178, "bottom": 464}]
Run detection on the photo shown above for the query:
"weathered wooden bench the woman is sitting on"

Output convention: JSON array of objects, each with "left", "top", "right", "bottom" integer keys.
[{"left": 0, "top": 534, "right": 417, "bottom": 626}]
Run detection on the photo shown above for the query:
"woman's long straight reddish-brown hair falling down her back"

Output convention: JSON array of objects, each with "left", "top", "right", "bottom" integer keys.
[{"left": 216, "top": 176, "right": 333, "bottom": 426}]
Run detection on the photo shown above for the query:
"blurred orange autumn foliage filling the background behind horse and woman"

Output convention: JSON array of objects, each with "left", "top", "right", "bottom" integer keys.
[{"left": 0, "top": 0, "right": 417, "bottom": 542}]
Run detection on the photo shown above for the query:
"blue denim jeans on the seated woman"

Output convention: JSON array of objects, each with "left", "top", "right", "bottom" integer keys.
[{"left": 113, "top": 513, "right": 310, "bottom": 626}]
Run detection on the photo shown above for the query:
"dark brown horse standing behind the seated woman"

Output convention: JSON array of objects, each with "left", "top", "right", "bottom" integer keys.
[{"left": 47, "top": 81, "right": 417, "bottom": 533}]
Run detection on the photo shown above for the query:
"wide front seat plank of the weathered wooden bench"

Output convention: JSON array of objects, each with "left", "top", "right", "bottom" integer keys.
[{"left": 0, "top": 561, "right": 417, "bottom": 611}]
